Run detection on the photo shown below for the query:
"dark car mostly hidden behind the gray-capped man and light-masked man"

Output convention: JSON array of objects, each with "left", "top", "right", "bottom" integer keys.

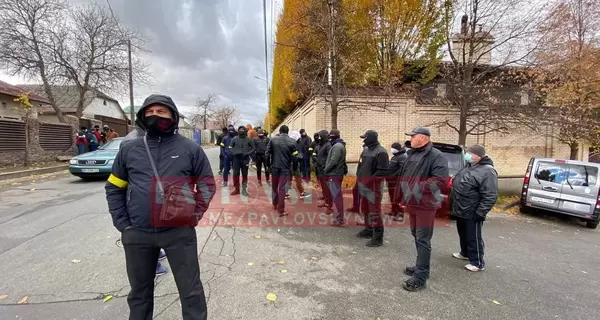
[{"left": 404, "top": 141, "right": 467, "bottom": 218}]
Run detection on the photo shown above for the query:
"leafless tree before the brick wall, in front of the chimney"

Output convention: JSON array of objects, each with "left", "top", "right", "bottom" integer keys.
[{"left": 436, "top": 0, "right": 546, "bottom": 145}]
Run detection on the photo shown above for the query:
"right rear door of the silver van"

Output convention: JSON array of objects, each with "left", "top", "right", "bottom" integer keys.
[{"left": 558, "top": 162, "right": 598, "bottom": 218}]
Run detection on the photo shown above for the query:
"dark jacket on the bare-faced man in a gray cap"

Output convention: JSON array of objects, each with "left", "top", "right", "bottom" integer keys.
[{"left": 396, "top": 142, "right": 450, "bottom": 210}]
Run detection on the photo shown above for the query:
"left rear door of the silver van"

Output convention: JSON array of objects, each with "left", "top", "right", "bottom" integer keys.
[{"left": 527, "top": 160, "right": 569, "bottom": 210}]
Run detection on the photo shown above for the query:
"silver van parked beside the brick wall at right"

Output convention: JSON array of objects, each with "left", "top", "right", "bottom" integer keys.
[{"left": 520, "top": 158, "right": 600, "bottom": 229}]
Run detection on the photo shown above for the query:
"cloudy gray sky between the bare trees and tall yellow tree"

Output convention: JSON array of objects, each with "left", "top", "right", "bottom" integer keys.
[{"left": 0, "top": 0, "right": 283, "bottom": 123}]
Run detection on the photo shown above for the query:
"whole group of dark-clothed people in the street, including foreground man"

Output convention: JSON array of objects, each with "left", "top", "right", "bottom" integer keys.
[{"left": 105, "top": 95, "right": 498, "bottom": 320}]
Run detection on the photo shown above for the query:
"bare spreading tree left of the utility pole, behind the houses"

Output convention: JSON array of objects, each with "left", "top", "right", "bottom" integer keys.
[{"left": 52, "top": 2, "right": 150, "bottom": 117}]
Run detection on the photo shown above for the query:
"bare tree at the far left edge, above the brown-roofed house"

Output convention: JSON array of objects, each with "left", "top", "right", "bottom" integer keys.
[{"left": 0, "top": 0, "right": 67, "bottom": 122}]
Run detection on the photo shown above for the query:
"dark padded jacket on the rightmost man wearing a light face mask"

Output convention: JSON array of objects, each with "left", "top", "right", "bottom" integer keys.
[{"left": 450, "top": 157, "right": 498, "bottom": 220}]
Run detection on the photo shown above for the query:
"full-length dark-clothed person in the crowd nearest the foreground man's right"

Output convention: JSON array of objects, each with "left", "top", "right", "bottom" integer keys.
[{"left": 229, "top": 126, "right": 255, "bottom": 196}]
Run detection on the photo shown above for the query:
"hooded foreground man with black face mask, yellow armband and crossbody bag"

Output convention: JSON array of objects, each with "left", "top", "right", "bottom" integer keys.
[{"left": 105, "top": 95, "right": 216, "bottom": 319}]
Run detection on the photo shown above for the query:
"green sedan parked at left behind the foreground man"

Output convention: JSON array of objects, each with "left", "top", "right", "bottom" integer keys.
[{"left": 69, "top": 138, "right": 123, "bottom": 180}]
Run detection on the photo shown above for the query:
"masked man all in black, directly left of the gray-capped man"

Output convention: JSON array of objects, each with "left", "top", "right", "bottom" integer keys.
[{"left": 356, "top": 130, "right": 389, "bottom": 247}]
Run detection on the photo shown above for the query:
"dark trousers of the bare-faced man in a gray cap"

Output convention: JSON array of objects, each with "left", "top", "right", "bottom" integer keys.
[{"left": 407, "top": 208, "right": 435, "bottom": 283}]
